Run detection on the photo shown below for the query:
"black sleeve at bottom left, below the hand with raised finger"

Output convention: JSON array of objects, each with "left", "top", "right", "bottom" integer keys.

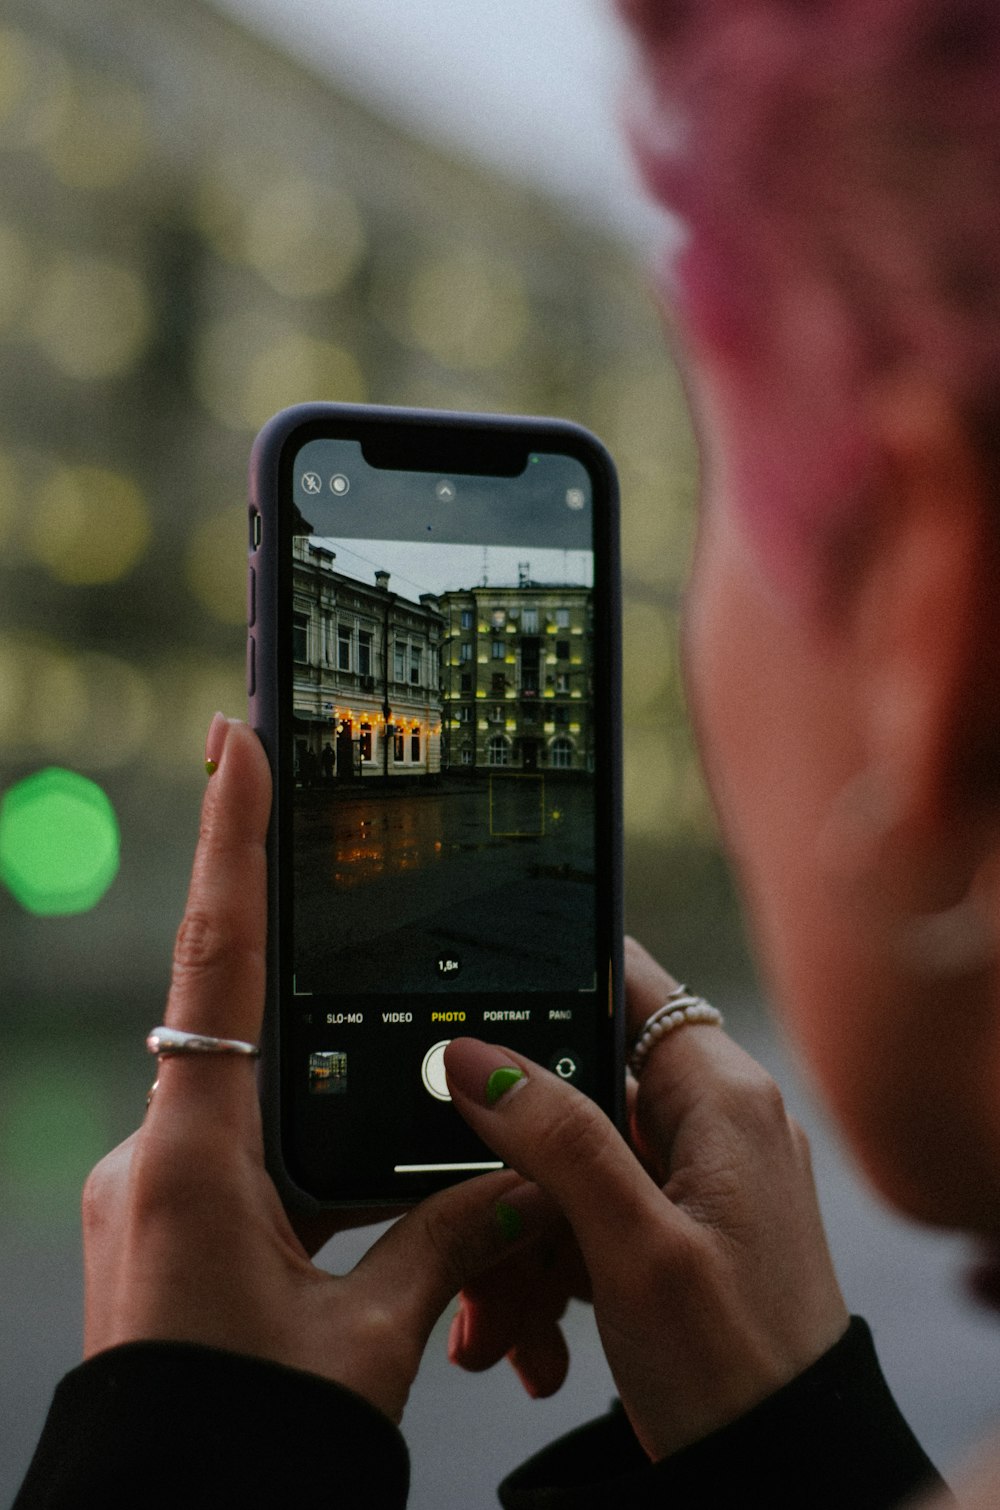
[{"left": 15, "top": 1342, "right": 409, "bottom": 1510}]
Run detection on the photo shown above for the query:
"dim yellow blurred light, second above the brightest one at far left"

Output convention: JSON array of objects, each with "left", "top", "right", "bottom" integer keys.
[{"left": 44, "top": 80, "right": 148, "bottom": 189}]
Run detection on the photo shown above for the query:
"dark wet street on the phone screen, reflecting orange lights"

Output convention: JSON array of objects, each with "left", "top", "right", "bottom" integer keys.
[{"left": 295, "top": 776, "right": 594, "bottom": 992}]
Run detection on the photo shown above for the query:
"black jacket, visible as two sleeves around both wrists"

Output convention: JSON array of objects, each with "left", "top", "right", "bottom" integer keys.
[{"left": 15, "top": 1318, "right": 941, "bottom": 1510}]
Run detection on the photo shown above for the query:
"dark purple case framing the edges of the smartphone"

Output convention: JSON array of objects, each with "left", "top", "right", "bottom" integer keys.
[{"left": 246, "top": 403, "right": 625, "bottom": 1213}]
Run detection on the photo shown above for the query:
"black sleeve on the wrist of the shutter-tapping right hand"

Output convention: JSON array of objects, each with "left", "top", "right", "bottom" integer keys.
[{"left": 500, "top": 1317, "right": 943, "bottom": 1510}]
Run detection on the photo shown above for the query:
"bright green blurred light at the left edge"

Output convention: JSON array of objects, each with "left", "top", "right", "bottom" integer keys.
[{"left": 0, "top": 766, "right": 119, "bottom": 918}]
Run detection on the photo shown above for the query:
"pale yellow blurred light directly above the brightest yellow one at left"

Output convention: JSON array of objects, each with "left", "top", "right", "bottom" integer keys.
[{"left": 32, "top": 257, "right": 153, "bottom": 379}]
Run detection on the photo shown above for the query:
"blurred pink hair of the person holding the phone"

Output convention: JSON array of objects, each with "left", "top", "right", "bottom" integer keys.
[{"left": 619, "top": 0, "right": 1000, "bottom": 586}]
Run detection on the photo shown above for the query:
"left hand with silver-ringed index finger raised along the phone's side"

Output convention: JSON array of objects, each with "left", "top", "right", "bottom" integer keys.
[{"left": 83, "top": 717, "right": 543, "bottom": 1419}]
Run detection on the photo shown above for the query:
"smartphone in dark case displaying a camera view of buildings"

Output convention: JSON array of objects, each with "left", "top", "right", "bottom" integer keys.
[{"left": 248, "top": 405, "right": 624, "bottom": 1206}]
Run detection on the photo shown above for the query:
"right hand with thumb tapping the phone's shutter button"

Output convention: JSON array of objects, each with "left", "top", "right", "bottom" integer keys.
[{"left": 446, "top": 939, "right": 847, "bottom": 1460}]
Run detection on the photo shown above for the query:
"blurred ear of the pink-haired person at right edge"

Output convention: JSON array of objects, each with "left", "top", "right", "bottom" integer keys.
[{"left": 823, "top": 373, "right": 1000, "bottom": 914}]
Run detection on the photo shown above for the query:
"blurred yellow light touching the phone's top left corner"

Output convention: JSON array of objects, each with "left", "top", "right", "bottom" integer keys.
[{"left": 195, "top": 314, "right": 367, "bottom": 430}]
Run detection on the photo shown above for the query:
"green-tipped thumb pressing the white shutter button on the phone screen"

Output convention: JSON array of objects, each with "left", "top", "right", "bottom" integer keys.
[{"left": 444, "top": 1037, "right": 669, "bottom": 1274}]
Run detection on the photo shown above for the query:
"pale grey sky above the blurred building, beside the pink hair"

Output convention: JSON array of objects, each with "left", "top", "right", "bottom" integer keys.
[{"left": 206, "top": 0, "right": 663, "bottom": 252}]
